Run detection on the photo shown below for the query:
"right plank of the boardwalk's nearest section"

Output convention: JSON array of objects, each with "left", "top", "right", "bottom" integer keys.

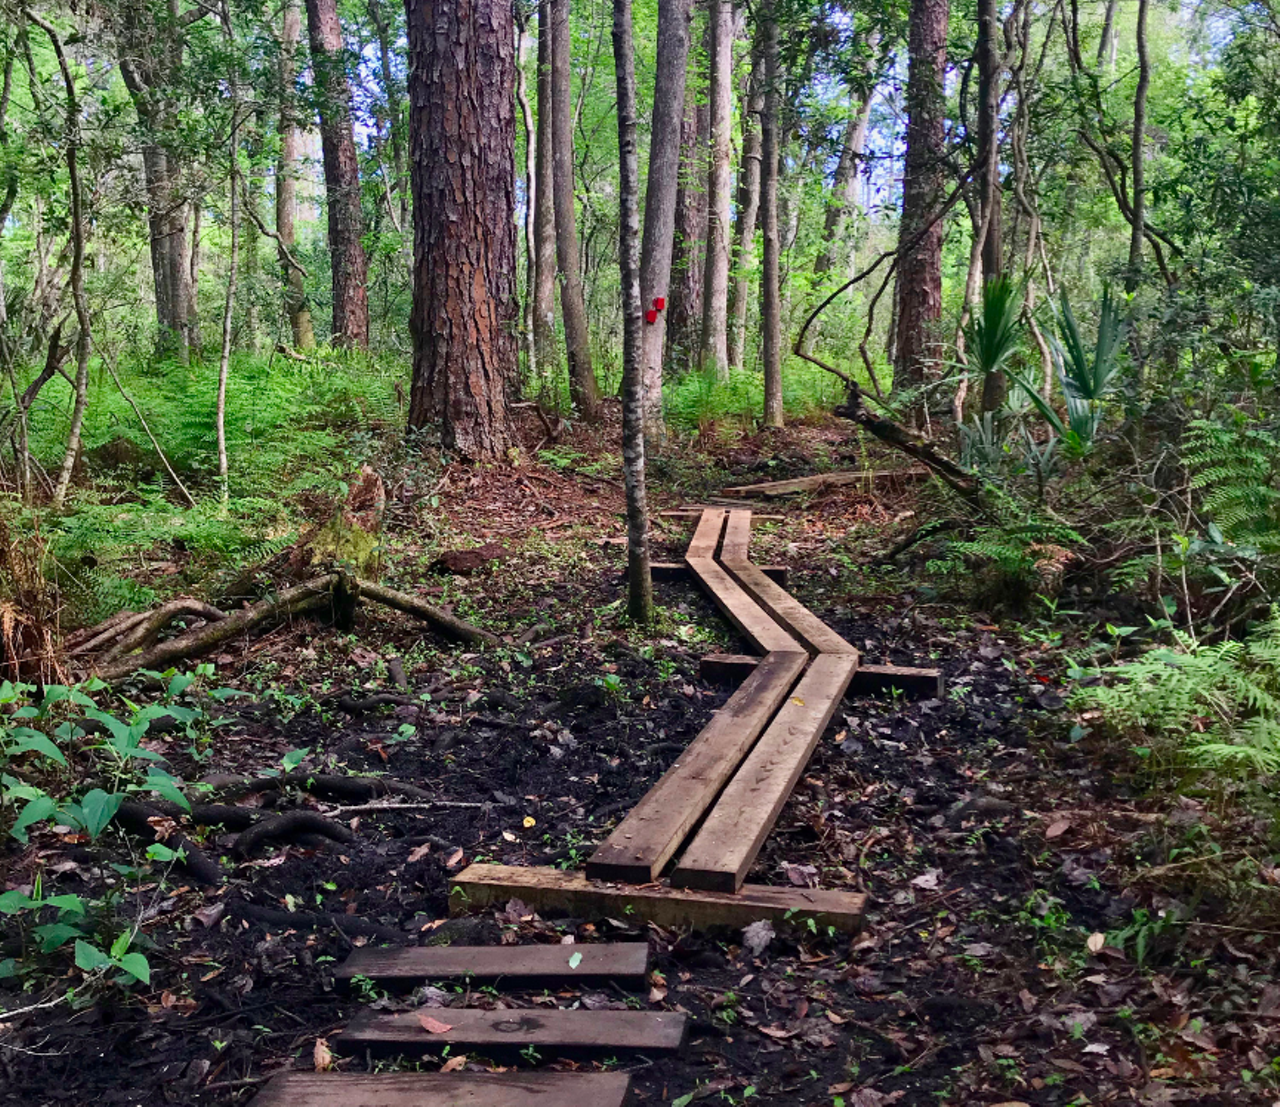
[{"left": 671, "top": 654, "right": 858, "bottom": 892}]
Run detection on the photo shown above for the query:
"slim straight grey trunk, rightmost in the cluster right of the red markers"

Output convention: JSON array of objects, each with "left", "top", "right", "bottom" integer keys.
[{"left": 759, "top": 0, "right": 782, "bottom": 426}]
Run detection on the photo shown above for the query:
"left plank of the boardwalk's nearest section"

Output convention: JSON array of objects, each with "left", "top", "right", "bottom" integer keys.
[{"left": 582, "top": 650, "right": 809, "bottom": 880}]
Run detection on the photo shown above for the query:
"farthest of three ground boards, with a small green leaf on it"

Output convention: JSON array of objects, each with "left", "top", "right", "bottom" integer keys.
[{"left": 334, "top": 942, "right": 649, "bottom": 987}]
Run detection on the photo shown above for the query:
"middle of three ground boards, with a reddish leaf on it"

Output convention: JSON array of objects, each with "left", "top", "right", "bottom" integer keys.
[{"left": 330, "top": 1007, "right": 689, "bottom": 1053}]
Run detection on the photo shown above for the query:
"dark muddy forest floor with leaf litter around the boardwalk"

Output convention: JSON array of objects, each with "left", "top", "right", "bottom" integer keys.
[{"left": 0, "top": 409, "right": 1280, "bottom": 1107}]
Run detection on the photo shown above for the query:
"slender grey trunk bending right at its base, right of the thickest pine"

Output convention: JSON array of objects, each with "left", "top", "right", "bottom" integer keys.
[{"left": 550, "top": 0, "right": 600, "bottom": 422}]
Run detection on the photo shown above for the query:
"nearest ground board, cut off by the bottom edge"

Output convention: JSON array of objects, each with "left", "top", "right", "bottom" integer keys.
[{"left": 253, "top": 1072, "right": 631, "bottom": 1107}]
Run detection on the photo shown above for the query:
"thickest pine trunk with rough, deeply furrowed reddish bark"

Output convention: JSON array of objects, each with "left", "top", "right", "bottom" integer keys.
[{"left": 407, "top": 0, "right": 516, "bottom": 459}]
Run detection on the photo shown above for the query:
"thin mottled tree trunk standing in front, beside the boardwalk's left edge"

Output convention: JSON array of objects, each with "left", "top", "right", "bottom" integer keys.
[{"left": 613, "top": 0, "right": 653, "bottom": 626}]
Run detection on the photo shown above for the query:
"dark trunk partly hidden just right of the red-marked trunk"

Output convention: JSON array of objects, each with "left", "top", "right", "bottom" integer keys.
[{"left": 664, "top": 47, "right": 710, "bottom": 375}]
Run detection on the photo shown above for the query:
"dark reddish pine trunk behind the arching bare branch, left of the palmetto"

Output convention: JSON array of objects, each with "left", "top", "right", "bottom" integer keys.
[{"left": 893, "top": 0, "right": 950, "bottom": 427}]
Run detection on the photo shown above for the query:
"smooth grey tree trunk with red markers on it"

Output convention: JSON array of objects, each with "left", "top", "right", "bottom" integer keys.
[{"left": 640, "top": 0, "right": 691, "bottom": 445}]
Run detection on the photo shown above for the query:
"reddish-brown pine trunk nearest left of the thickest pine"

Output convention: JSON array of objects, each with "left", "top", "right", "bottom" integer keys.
[{"left": 307, "top": 0, "right": 369, "bottom": 349}]
